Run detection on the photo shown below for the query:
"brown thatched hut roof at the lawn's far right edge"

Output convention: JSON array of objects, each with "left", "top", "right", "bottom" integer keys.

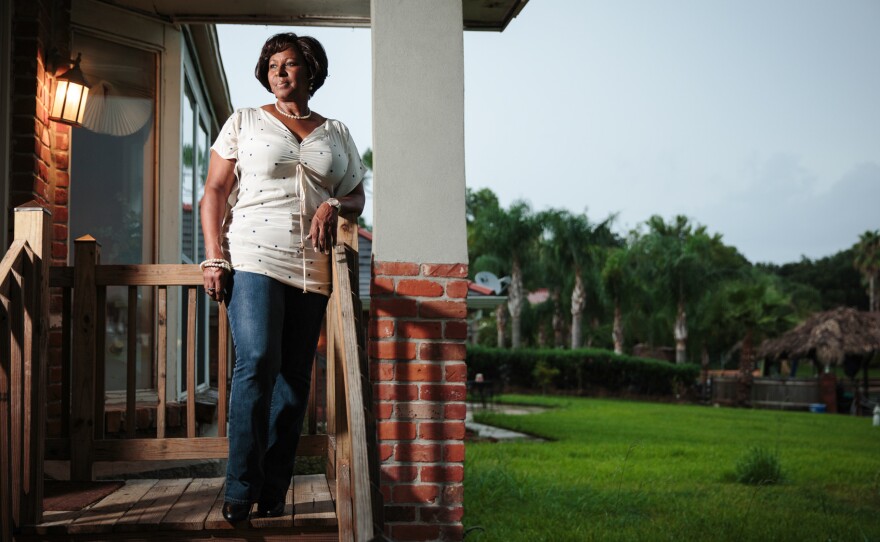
[{"left": 758, "top": 307, "right": 880, "bottom": 365}]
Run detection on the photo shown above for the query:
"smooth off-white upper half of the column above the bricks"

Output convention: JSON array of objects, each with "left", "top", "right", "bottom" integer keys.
[{"left": 371, "top": 0, "right": 467, "bottom": 263}]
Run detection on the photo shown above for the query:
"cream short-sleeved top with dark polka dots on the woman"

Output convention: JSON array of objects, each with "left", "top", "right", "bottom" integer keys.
[{"left": 211, "top": 108, "right": 365, "bottom": 295}]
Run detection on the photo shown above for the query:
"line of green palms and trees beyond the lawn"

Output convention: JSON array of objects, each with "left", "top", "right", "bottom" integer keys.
[{"left": 467, "top": 188, "right": 880, "bottom": 370}]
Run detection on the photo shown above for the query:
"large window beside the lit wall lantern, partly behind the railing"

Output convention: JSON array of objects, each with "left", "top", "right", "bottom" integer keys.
[{"left": 69, "top": 32, "right": 158, "bottom": 391}]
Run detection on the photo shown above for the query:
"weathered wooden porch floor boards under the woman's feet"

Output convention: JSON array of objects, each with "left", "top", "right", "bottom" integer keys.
[{"left": 21, "top": 474, "right": 338, "bottom": 541}]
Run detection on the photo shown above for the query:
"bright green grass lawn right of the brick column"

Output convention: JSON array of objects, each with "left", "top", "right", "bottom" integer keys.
[{"left": 464, "top": 396, "right": 880, "bottom": 542}]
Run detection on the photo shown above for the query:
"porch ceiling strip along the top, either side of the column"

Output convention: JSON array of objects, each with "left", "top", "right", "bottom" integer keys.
[{"left": 96, "top": 0, "right": 528, "bottom": 31}]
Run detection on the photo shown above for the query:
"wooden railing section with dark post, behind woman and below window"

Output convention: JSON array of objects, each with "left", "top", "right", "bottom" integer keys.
[{"left": 46, "top": 240, "right": 262, "bottom": 474}]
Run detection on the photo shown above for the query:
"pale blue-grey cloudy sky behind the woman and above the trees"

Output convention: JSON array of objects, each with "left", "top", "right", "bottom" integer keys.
[{"left": 219, "top": 0, "right": 880, "bottom": 263}]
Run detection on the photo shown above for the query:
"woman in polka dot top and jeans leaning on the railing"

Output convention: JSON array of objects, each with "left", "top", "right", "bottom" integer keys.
[{"left": 201, "top": 33, "right": 364, "bottom": 522}]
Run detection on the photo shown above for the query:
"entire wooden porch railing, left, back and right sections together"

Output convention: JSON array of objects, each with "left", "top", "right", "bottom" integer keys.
[{"left": 0, "top": 205, "right": 382, "bottom": 540}]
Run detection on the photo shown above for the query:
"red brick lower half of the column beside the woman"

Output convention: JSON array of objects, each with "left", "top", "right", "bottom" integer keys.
[{"left": 370, "top": 261, "right": 467, "bottom": 540}]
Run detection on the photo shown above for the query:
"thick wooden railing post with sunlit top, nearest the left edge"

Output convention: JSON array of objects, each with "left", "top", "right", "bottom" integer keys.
[{"left": 15, "top": 201, "right": 52, "bottom": 524}]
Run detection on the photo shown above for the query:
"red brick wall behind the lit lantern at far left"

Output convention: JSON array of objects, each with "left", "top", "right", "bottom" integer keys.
[{"left": 9, "top": 0, "right": 70, "bottom": 436}]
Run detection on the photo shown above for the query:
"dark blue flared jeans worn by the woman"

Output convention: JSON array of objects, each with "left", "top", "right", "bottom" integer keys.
[{"left": 225, "top": 271, "right": 328, "bottom": 506}]
